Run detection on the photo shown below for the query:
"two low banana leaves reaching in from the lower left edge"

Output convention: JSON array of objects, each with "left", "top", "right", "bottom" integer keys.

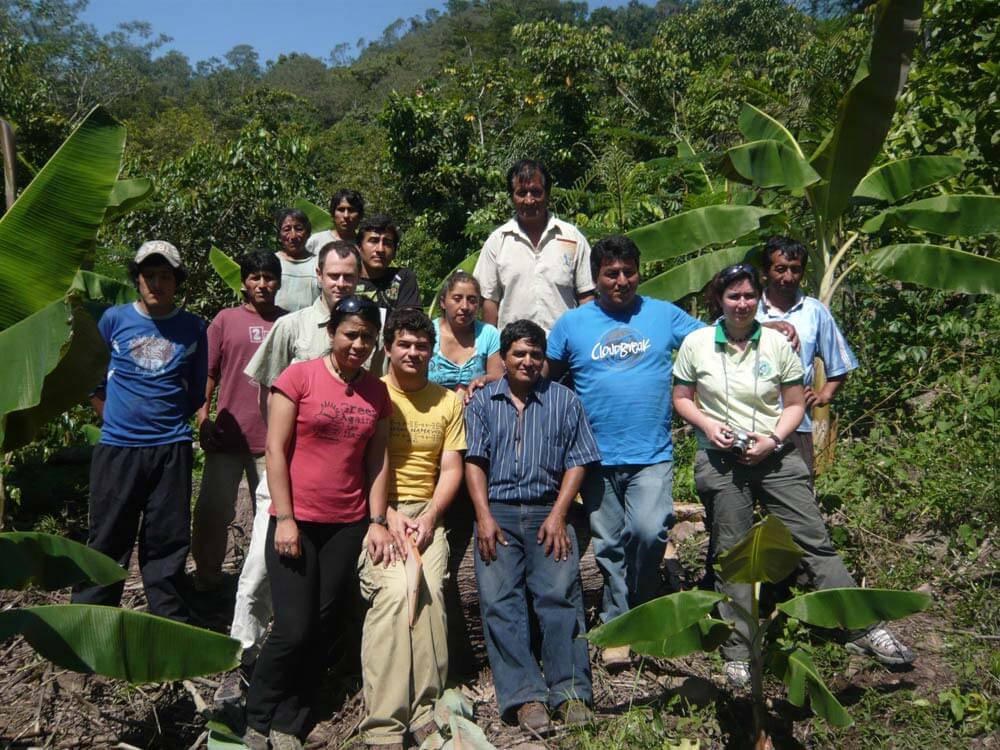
[{"left": 0, "top": 533, "right": 240, "bottom": 683}]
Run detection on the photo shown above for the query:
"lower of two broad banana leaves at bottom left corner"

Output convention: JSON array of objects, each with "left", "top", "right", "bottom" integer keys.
[{"left": 0, "top": 604, "right": 240, "bottom": 683}]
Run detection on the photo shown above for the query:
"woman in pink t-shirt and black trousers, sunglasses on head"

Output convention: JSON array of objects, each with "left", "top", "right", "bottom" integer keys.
[{"left": 244, "top": 297, "right": 396, "bottom": 748}]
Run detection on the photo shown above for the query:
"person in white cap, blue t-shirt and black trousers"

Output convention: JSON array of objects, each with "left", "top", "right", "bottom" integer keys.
[{"left": 73, "top": 240, "right": 208, "bottom": 621}]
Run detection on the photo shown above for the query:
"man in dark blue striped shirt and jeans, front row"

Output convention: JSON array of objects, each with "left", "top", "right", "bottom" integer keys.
[{"left": 465, "top": 320, "right": 601, "bottom": 732}]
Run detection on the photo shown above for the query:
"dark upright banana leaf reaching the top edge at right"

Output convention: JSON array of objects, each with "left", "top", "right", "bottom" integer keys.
[{"left": 810, "top": 0, "right": 923, "bottom": 221}]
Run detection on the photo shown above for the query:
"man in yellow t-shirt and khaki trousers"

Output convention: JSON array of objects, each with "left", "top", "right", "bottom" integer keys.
[{"left": 359, "top": 308, "right": 465, "bottom": 750}]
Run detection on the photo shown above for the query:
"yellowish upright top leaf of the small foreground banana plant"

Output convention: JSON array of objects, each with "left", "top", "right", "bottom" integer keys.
[{"left": 718, "top": 515, "right": 802, "bottom": 583}]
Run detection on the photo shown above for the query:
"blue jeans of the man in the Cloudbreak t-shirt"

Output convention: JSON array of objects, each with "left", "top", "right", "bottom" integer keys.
[{"left": 581, "top": 461, "right": 674, "bottom": 622}]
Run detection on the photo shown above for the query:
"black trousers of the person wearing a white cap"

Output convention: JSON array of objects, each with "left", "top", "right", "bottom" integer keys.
[{"left": 72, "top": 442, "right": 192, "bottom": 622}]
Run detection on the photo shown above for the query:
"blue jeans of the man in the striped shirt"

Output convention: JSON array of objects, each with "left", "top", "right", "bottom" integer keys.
[{"left": 473, "top": 503, "right": 592, "bottom": 715}]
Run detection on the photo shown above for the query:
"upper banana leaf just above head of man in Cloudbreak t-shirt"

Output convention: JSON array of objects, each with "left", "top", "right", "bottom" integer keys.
[{"left": 627, "top": 205, "right": 778, "bottom": 263}]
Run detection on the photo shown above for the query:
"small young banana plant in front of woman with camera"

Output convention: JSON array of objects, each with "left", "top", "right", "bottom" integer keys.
[{"left": 586, "top": 516, "right": 930, "bottom": 747}]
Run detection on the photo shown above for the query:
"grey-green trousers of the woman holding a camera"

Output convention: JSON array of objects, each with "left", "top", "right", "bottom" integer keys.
[{"left": 694, "top": 450, "right": 861, "bottom": 661}]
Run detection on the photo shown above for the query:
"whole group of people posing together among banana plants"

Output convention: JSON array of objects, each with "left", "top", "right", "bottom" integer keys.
[{"left": 73, "top": 160, "right": 913, "bottom": 750}]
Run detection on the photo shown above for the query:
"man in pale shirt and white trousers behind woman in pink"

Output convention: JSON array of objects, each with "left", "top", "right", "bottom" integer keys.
[{"left": 215, "top": 240, "right": 361, "bottom": 706}]
